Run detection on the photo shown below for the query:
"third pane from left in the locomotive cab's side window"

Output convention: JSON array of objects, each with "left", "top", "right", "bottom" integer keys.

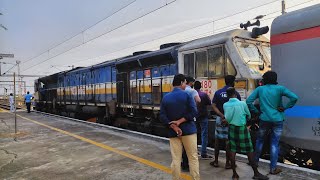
[{"left": 208, "top": 46, "right": 224, "bottom": 77}]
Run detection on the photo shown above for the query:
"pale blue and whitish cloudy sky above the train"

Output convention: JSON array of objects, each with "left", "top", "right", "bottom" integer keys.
[{"left": 0, "top": 0, "right": 320, "bottom": 95}]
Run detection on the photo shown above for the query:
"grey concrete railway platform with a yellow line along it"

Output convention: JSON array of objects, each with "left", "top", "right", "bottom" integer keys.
[{"left": 0, "top": 109, "right": 320, "bottom": 180}]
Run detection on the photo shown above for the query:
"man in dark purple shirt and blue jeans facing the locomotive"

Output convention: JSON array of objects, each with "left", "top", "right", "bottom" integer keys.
[{"left": 194, "top": 81, "right": 212, "bottom": 159}]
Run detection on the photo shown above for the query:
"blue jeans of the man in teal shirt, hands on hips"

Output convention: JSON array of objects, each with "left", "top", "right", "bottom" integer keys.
[{"left": 255, "top": 120, "right": 283, "bottom": 171}]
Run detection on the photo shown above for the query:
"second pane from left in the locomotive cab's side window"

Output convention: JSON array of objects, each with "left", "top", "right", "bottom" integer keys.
[{"left": 196, "top": 51, "right": 208, "bottom": 78}]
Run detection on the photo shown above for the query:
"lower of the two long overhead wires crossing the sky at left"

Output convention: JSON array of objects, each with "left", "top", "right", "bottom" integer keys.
[{"left": 22, "top": 0, "right": 177, "bottom": 72}]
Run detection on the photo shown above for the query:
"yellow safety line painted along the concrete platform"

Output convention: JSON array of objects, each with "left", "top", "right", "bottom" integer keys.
[{"left": 17, "top": 115, "right": 191, "bottom": 180}]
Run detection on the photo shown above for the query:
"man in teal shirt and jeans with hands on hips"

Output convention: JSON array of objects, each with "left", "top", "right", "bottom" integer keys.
[{"left": 247, "top": 71, "right": 298, "bottom": 174}]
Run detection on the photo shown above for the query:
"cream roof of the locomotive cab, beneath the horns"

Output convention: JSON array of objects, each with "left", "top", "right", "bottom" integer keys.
[{"left": 179, "top": 29, "right": 269, "bottom": 51}]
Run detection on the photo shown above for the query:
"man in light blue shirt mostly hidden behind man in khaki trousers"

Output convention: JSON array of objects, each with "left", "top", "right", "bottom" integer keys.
[{"left": 181, "top": 76, "right": 201, "bottom": 171}]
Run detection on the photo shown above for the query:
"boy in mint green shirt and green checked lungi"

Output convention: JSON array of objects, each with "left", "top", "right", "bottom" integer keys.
[{"left": 223, "top": 87, "right": 269, "bottom": 180}]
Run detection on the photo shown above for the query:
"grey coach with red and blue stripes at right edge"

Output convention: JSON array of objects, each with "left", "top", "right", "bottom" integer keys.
[{"left": 271, "top": 4, "right": 320, "bottom": 170}]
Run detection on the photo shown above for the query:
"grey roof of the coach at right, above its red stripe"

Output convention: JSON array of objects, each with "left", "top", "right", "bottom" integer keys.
[{"left": 271, "top": 4, "right": 320, "bottom": 35}]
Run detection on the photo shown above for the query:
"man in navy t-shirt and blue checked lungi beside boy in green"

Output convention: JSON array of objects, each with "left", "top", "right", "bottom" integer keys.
[{"left": 210, "top": 75, "right": 241, "bottom": 169}]
